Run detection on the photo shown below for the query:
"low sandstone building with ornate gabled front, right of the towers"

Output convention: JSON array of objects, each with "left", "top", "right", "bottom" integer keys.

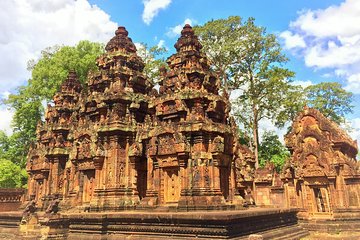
[{"left": 282, "top": 108, "right": 360, "bottom": 217}]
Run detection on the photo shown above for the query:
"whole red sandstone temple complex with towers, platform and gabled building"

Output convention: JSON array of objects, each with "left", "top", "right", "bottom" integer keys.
[{"left": 17, "top": 25, "right": 360, "bottom": 239}]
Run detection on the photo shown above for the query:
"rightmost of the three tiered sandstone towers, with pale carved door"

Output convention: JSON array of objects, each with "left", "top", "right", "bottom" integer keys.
[{"left": 143, "top": 25, "right": 234, "bottom": 208}]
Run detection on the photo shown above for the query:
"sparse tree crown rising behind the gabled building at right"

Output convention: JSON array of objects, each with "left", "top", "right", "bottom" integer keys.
[{"left": 305, "top": 82, "right": 354, "bottom": 124}]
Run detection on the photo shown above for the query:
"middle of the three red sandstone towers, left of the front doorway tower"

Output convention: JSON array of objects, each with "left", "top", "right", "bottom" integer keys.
[{"left": 80, "top": 27, "right": 152, "bottom": 210}]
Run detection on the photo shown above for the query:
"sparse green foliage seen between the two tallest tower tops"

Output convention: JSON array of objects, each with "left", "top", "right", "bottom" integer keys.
[{"left": 137, "top": 43, "right": 167, "bottom": 85}]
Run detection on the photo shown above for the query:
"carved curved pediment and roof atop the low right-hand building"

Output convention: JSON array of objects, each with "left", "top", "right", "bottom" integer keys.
[{"left": 284, "top": 108, "right": 358, "bottom": 178}]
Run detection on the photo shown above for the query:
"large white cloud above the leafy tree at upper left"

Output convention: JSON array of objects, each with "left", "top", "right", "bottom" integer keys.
[{"left": 0, "top": 0, "right": 117, "bottom": 133}]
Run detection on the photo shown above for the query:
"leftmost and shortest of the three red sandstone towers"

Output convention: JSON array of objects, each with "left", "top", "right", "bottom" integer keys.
[{"left": 26, "top": 72, "right": 82, "bottom": 207}]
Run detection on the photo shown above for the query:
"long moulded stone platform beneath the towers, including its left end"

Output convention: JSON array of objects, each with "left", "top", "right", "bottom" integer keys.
[{"left": 0, "top": 208, "right": 309, "bottom": 240}]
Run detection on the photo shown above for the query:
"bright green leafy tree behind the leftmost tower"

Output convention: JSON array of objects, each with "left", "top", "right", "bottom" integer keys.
[{"left": 4, "top": 41, "right": 104, "bottom": 167}]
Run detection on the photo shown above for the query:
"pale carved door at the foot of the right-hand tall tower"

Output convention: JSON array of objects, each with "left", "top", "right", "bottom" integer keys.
[{"left": 164, "top": 168, "right": 181, "bottom": 204}]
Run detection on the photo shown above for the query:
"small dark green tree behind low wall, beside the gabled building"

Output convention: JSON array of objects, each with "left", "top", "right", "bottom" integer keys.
[{"left": 259, "top": 131, "right": 290, "bottom": 172}]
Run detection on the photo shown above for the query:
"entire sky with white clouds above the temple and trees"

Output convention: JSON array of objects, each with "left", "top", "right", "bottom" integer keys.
[{"left": 0, "top": 0, "right": 360, "bottom": 140}]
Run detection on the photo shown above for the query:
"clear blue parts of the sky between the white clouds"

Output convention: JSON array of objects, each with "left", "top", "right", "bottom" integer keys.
[{"left": 86, "top": 0, "right": 346, "bottom": 86}]
